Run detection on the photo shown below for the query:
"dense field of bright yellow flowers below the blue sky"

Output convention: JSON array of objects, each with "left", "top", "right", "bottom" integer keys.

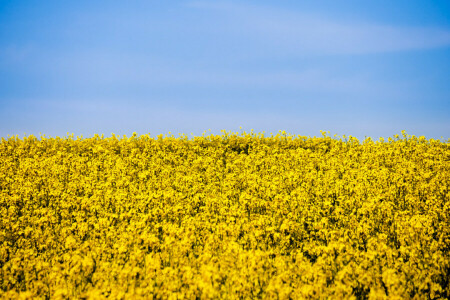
[{"left": 0, "top": 131, "right": 450, "bottom": 299}]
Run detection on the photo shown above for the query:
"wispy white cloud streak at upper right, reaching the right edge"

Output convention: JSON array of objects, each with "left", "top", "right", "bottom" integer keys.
[{"left": 189, "top": 1, "right": 450, "bottom": 55}]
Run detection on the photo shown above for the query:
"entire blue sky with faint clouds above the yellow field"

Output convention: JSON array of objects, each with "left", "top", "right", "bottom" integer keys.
[{"left": 0, "top": 0, "right": 450, "bottom": 139}]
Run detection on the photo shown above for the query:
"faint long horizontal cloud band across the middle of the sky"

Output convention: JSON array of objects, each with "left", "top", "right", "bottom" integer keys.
[{"left": 51, "top": 54, "right": 393, "bottom": 95}]
